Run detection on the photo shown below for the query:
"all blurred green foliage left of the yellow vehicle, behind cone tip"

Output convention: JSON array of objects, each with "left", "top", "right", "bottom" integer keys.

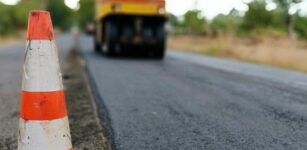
[{"left": 0, "top": 0, "right": 95, "bottom": 36}]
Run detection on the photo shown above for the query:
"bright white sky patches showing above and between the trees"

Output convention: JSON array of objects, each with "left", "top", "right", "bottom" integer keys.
[{"left": 0, "top": 0, "right": 307, "bottom": 19}]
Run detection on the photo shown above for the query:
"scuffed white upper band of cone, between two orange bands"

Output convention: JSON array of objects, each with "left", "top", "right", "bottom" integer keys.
[{"left": 22, "top": 40, "right": 63, "bottom": 92}]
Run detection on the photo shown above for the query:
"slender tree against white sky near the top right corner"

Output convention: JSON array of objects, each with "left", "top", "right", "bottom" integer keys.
[{"left": 274, "top": 0, "right": 302, "bottom": 38}]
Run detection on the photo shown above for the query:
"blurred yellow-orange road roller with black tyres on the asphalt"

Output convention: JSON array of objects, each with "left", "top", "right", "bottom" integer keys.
[{"left": 95, "top": 0, "right": 167, "bottom": 59}]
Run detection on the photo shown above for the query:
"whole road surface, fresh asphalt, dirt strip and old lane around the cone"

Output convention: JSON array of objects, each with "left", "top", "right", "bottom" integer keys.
[{"left": 0, "top": 35, "right": 307, "bottom": 150}]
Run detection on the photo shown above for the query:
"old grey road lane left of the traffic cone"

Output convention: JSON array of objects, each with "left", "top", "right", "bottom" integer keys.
[{"left": 0, "top": 40, "right": 25, "bottom": 150}]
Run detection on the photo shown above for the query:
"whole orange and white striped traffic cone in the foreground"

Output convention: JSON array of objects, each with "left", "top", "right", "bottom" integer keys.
[{"left": 18, "top": 10, "right": 72, "bottom": 150}]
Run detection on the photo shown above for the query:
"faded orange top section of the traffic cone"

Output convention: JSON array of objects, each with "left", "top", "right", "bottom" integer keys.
[{"left": 27, "top": 10, "right": 54, "bottom": 40}]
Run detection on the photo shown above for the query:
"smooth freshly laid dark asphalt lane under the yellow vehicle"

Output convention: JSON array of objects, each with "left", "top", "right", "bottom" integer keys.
[{"left": 79, "top": 34, "right": 307, "bottom": 150}]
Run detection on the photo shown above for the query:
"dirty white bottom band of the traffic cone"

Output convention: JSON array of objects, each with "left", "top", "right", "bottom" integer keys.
[{"left": 18, "top": 117, "right": 72, "bottom": 150}]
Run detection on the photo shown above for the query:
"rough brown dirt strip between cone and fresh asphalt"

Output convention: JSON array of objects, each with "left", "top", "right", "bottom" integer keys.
[{"left": 62, "top": 50, "right": 111, "bottom": 150}]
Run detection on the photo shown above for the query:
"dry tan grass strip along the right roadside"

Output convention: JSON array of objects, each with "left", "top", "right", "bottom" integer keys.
[{"left": 168, "top": 35, "right": 307, "bottom": 72}]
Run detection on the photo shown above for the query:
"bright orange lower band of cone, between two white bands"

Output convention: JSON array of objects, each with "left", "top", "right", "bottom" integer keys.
[{"left": 21, "top": 90, "right": 67, "bottom": 120}]
